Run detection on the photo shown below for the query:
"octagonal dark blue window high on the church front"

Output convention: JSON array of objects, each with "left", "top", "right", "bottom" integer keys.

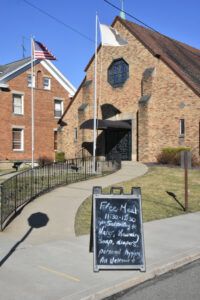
[{"left": 108, "top": 58, "right": 129, "bottom": 87}]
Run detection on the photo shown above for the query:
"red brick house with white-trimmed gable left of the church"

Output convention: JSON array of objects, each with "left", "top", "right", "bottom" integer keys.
[{"left": 0, "top": 58, "right": 75, "bottom": 168}]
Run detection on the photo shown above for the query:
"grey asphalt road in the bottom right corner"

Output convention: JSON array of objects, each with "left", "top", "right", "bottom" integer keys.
[{"left": 107, "top": 260, "right": 200, "bottom": 300}]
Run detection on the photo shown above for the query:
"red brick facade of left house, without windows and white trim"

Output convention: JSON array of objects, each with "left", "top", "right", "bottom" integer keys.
[{"left": 0, "top": 64, "right": 70, "bottom": 160}]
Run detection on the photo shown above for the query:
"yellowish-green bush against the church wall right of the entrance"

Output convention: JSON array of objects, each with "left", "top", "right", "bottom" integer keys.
[{"left": 157, "top": 147, "right": 191, "bottom": 166}]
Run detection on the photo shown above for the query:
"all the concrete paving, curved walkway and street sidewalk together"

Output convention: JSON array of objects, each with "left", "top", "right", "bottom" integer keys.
[{"left": 0, "top": 163, "right": 200, "bottom": 300}]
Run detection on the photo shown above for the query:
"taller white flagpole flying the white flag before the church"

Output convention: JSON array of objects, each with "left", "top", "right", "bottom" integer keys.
[{"left": 93, "top": 14, "right": 98, "bottom": 173}]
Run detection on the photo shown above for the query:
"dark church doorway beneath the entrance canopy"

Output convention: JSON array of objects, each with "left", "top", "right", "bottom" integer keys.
[{"left": 105, "top": 129, "right": 132, "bottom": 160}]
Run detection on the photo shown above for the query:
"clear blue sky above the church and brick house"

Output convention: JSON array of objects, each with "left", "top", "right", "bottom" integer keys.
[{"left": 0, "top": 0, "right": 200, "bottom": 87}]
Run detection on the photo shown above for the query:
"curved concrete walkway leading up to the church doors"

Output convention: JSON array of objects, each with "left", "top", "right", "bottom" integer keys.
[{"left": 0, "top": 162, "right": 148, "bottom": 244}]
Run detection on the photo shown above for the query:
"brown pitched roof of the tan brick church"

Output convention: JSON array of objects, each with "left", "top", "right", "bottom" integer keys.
[{"left": 118, "top": 17, "right": 200, "bottom": 96}]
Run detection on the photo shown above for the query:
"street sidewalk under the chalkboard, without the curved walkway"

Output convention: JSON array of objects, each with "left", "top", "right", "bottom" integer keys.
[{"left": 0, "top": 213, "right": 200, "bottom": 300}]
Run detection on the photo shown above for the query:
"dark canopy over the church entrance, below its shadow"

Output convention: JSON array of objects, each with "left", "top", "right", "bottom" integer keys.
[{"left": 80, "top": 119, "right": 131, "bottom": 130}]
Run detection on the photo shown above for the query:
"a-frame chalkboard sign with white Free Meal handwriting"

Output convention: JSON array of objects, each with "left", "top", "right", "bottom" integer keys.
[{"left": 92, "top": 187, "right": 146, "bottom": 272}]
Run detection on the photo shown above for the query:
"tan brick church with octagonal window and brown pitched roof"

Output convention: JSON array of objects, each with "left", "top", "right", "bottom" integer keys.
[{"left": 58, "top": 17, "right": 200, "bottom": 162}]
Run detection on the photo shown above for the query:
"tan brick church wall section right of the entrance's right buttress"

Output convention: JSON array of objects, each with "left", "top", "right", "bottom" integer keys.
[{"left": 139, "top": 61, "right": 200, "bottom": 162}]
